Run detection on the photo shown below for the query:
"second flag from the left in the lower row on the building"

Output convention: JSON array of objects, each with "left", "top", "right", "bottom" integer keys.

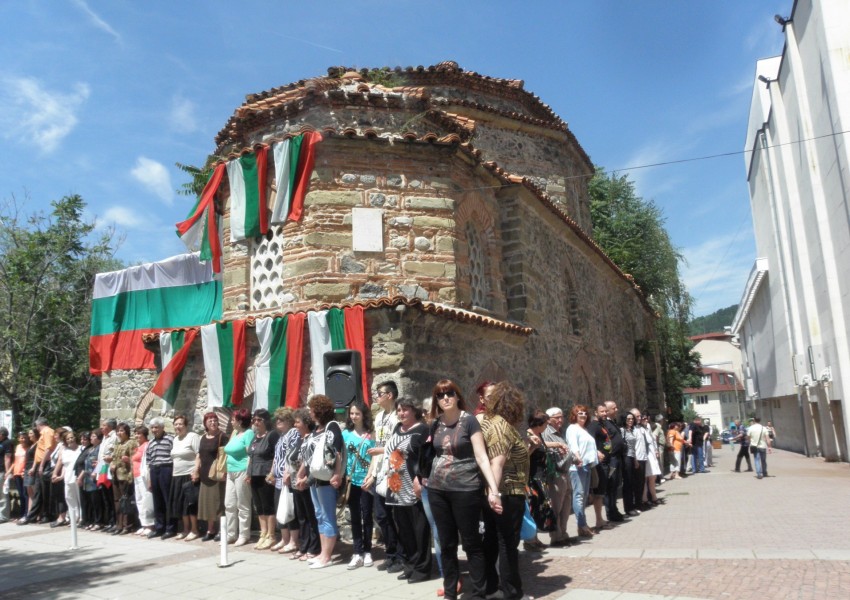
[{"left": 201, "top": 321, "right": 247, "bottom": 408}]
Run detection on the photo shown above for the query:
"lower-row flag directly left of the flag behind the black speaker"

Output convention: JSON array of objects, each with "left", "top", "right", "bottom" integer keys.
[{"left": 253, "top": 313, "right": 304, "bottom": 412}]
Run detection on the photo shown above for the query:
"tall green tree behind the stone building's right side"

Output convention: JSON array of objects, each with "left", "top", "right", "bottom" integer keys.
[{"left": 589, "top": 168, "right": 700, "bottom": 416}]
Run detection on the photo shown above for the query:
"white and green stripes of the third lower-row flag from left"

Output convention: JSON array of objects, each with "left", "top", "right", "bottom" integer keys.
[{"left": 252, "top": 317, "right": 288, "bottom": 413}]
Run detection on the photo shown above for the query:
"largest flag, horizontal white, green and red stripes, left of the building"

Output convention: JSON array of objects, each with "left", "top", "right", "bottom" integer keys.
[{"left": 89, "top": 254, "right": 222, "bottom": 375}]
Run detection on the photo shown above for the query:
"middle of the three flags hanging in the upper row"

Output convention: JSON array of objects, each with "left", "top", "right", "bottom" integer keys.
[{"left": 227, "top": 146, "right": 269, "bottom": 242}]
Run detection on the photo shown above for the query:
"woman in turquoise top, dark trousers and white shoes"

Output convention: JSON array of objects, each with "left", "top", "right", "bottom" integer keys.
[{"left": 342, "top": 402, "right": 375, "bottom": 570}]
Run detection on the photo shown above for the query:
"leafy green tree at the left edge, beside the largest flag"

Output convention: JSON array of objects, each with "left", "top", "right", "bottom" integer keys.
[{"left": 0, "top": 196, "right": 120, "bottom": 430}]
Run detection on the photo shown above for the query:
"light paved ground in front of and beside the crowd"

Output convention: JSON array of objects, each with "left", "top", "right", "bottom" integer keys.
[{"left": 0, "top": 446, "right": 850, "bottom": 600}]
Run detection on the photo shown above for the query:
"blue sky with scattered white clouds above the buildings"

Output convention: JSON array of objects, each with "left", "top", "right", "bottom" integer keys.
[{"left": 0, "top": 0, "right": 793, "bottom": 316}]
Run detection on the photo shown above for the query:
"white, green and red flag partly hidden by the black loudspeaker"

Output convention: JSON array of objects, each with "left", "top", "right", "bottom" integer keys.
[{"left": 308, "top": 306, "right": 371, "bottom": 406}]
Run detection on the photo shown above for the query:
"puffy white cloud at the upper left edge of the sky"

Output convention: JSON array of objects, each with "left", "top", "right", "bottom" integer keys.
[{"left": 0, "top": 77, "right": 91, "bottom": 154}]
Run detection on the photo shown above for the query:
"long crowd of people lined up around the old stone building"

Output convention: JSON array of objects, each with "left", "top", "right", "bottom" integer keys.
[{"left": 0, "top": 379, "right": 775, "bottom": 599}]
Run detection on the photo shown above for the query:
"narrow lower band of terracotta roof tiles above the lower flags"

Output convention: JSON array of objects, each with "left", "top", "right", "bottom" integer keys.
[{"left": 142, "top": 296, "right": 534, "bottom": 343}]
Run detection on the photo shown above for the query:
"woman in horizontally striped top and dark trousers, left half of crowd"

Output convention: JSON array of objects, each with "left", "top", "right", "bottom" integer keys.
[{"left": 145, "top": 417, "right": 179, "bottom": 539}]
